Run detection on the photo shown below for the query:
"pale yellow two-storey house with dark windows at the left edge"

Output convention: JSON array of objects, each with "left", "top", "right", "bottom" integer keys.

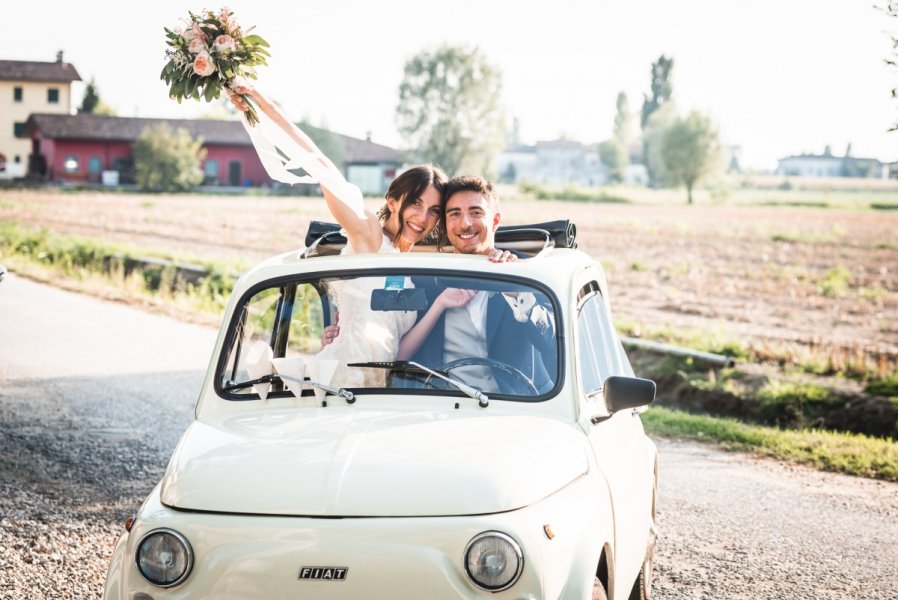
[{"left": 0, "top": 52, "right": 81, "bottom": 177}]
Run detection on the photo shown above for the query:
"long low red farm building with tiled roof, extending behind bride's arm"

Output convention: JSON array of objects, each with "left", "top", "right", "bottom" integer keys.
[{"left": 13, "top": 114, "right": 400, "bottom": 195}]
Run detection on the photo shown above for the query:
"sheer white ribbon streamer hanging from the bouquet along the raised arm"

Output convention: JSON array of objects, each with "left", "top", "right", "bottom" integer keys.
[{"left": 240, "top": 111, "right": 366, "bottom": 219}]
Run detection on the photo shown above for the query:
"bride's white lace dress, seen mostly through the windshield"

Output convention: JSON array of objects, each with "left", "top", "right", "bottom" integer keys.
[{"left": 318, "top": 236, "right": 417, "bottom": 387}]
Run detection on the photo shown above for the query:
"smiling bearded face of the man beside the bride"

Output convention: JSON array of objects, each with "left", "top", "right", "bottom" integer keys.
[{"left": 445, "top": 190, "right": 499, "bottom": 254}]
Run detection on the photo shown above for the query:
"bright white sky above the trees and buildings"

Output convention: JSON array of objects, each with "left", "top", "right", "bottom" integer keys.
[{"left": 0, "top": 0, "right": 898, "bottom": 169}]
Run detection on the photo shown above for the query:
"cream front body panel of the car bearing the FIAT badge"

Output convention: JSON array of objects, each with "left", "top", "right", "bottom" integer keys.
[{"left": 104, "top": 477, "right": 613, "bottom": 600}]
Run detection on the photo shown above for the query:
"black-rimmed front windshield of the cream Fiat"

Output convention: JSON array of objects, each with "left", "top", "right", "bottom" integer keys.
[{"left": 216, "top": 271, "right": 560, "bottom": 401}]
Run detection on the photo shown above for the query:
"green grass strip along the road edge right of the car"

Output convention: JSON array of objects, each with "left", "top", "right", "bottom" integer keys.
[{"left": 642, "top": 407, "right": 898, "bottom": 481}]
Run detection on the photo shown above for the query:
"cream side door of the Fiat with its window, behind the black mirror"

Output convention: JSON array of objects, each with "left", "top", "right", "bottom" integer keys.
[{"left": 574, "top": 280, "right": 654, "bottom": 597}]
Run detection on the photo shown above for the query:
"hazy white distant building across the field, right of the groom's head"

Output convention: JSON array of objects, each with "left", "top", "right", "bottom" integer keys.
[{"left": 496, "top": 140, "right": 608, "bottom": 187}]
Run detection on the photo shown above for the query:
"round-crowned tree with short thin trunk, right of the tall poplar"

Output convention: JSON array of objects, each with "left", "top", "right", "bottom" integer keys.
[{"left": 661, "top": 112, "right": 720, "bottom": 204}]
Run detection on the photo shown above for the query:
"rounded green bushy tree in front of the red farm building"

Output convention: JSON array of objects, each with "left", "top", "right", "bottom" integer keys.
[{"left": 134, "top": 123, "right": 206, "bottom": 192}]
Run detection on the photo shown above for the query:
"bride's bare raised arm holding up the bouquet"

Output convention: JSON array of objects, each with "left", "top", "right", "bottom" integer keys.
[{"left": 230, "top": 86, "right": 383, "bottom": 252}]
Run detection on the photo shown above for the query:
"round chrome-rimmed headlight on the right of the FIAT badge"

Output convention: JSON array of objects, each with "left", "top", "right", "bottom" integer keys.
[{"left": 465, "top": 531, "right": 524, "bottom": 592}]
